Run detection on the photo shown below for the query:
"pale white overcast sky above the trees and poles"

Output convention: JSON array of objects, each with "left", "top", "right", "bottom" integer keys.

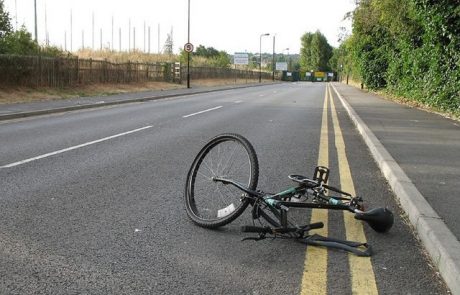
[{"left": 4, "top": 0, "right": 355, "bottom": 54}]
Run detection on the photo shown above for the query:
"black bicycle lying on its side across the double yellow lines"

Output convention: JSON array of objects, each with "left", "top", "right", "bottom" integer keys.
[{"left": 184, "top": 133, "right": 394, "bottom": 256}]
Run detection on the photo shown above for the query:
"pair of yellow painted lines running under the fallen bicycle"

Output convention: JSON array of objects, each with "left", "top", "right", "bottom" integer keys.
[{"left": 301, "top": 84, "right": 378, "bottom": 294}]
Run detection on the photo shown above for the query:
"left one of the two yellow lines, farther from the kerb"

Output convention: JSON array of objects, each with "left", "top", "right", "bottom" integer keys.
[{"left": 300, "top": 84, "right": 329, "bottom": 294}]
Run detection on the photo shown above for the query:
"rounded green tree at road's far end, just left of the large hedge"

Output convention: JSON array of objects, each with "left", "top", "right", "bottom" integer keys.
[{"left": 300, "top": 31, "right": 332, "bottom": 71}]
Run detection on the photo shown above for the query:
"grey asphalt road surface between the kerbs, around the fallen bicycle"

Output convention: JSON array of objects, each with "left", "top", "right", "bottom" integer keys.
[{"left": 0, "top": 83, "right": 447, "bottom": 294}]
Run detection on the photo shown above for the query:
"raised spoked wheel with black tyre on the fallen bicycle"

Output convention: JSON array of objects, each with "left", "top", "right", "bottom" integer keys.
[{"left": 185, "top": 134, "right": 259, "bottom": 228}]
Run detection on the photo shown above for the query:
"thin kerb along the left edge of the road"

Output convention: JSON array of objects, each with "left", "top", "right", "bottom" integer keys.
[{"left": 0, "top": 83, "right": 273, "bottom": 121}]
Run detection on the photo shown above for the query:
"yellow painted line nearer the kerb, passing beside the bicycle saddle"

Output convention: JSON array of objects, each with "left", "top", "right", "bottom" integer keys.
[{"left": 328, "top": 85, "right": 378, "bottom": 294}]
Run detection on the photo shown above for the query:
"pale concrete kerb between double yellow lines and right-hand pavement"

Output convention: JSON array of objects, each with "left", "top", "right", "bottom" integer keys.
[{"left": 331, "top": 84, "right": 460, "bottom": 294}]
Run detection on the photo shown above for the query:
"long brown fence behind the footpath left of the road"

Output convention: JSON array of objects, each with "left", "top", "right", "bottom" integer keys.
[{"left": 0, "top": 54, "right": 271, "bottom": 88}]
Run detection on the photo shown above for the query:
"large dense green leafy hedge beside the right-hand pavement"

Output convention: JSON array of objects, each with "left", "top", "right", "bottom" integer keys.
[{"left": 330, "top": 0, "right": 460, "bottom": 117}]
